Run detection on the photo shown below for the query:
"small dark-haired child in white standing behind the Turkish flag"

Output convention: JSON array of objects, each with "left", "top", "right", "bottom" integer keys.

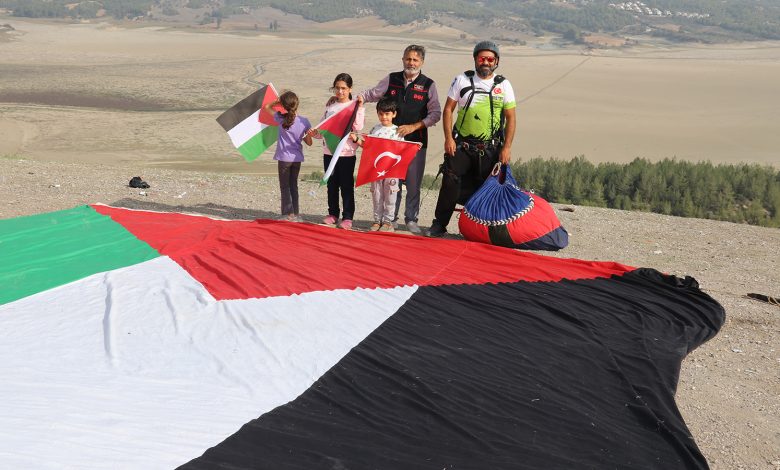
[{"left": 358, "top": 97, "right": 403, "bottom": 232}]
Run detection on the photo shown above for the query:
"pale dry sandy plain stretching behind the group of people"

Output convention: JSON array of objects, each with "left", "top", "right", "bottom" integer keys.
[{"left": 0, "top": 18, "right": 780, "bottom": 173}]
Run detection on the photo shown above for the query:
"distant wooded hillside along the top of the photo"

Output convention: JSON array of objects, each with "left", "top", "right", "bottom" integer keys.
[{"left": 0, "top": 0, "right": 780, "bottom": 41}]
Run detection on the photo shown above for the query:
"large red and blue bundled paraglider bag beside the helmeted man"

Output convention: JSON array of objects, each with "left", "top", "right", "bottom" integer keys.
[{"left": 458, "top": 165, "right": 569, "bottom": 251}]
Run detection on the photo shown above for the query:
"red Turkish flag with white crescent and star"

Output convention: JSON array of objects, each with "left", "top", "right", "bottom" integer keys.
[{"left": 355, "top": 135, "right": 422, "bottom": 187}]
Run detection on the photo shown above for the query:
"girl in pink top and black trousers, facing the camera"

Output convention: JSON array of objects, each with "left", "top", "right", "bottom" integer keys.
[{"left": 315, "top": 73, "right": 365, "bottom": 230}]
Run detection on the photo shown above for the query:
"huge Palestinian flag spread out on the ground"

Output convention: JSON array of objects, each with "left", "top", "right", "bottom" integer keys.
[{"left": 0, "top": 206, "right": 724, "bottom": 470}]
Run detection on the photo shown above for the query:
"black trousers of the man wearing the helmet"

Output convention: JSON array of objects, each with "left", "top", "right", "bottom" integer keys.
[{"left": 435, "top": 142, "right": 501, "bottom": 228}]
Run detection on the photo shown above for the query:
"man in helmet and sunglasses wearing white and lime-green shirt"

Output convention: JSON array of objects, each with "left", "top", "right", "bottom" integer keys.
[{"left": 428, "top": 41, "right": 516, "bottom": 237}]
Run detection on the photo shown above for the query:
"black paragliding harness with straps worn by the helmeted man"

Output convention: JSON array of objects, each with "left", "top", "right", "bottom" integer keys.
[{"left": 436, "top": 70, "right": 505, "bottom": 198}]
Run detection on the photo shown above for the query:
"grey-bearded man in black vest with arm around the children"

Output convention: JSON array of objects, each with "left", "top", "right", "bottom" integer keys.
[{"left": 357, "top": 44, "right": 441, "bottom": 235}]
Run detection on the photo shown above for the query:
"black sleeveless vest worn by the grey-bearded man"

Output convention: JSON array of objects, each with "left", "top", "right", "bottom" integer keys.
[{"left": 385, "top": 71, "right": 433, "bottom": 148}]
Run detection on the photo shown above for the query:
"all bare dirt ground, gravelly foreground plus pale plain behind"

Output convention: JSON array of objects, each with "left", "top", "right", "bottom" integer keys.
[{"left": 0, "top": 17, "right": 780, "bottom": 470}]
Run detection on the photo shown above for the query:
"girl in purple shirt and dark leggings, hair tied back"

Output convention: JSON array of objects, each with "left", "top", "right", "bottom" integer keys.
[{"left": 263, "top": 91, "right": 312, "bottom": 222}]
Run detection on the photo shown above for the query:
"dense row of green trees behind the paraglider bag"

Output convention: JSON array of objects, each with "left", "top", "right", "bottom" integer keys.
[{"left": 513, "top": 157, "right": 780, "bottom": 227}]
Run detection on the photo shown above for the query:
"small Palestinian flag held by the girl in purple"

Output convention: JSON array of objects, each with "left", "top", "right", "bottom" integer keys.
[{"left": 217, "top": 83, "right": 279, "bottom": 162}]
